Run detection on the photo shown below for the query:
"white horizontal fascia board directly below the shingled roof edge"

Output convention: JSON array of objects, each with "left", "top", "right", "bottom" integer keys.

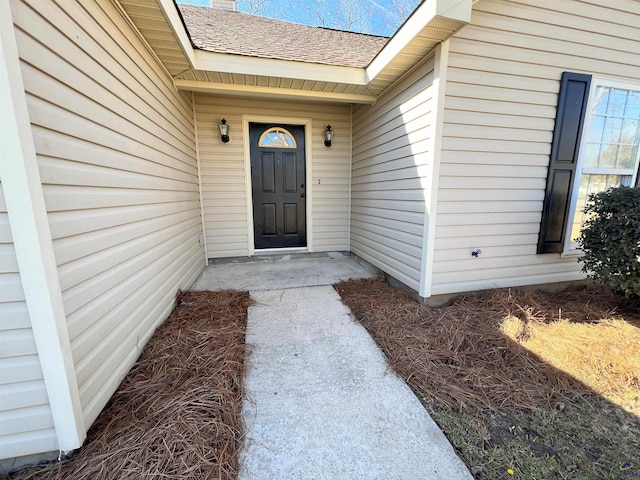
[{"left": 194, "top": 50, "right": 367, "bottom": 85}]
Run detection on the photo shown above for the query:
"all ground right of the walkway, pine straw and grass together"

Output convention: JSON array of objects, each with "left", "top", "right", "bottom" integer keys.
[{"left": 336, "top": 279, "right": 640, "bottom": 480}]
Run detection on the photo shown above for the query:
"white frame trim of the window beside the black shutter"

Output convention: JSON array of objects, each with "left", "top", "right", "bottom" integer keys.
[{"left": 562, "top": 77, "right": 640, "bottom": 257}]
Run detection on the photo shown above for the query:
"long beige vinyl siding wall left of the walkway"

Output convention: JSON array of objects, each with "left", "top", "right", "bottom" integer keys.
[{"left": 12, "top": 0, "right": 204, "bottom": 426}]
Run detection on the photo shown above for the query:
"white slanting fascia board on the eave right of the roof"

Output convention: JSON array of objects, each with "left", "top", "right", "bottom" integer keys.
[{"left": 366, "top": 0, "right": 472, "bottom": 82}]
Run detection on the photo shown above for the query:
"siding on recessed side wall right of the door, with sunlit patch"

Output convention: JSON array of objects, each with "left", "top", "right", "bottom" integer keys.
[{"left": 351, "top": 58, "right": 435, "bottom": 290}]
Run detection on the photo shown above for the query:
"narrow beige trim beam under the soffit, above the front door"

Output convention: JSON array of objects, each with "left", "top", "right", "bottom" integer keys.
[{"left": 173, "top": 80, "right": 376, "bottom": 105}]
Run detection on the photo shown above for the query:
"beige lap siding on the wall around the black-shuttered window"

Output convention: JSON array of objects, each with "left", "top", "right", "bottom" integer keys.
[{"left": 433, "top": 0, "right": 640, "bottom": 294}]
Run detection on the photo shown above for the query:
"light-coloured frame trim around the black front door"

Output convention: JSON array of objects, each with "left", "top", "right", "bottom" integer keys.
[{"left": 242, "top": 114, "right": 313, "bottom": 257}]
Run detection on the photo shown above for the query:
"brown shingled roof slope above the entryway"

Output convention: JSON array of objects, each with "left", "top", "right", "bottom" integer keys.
[{"left": 178, "top": 5, "right": 388, "bottom": 67}]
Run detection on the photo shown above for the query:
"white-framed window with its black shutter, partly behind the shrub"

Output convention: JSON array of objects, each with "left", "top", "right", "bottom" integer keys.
[{"left": 538, "top": 72, "right": 640, "bottom": 253}]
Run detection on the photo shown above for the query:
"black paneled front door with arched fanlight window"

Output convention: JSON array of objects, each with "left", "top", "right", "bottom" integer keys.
[{"left": 249, "top": 123, "right": 307, "bottom": 249}]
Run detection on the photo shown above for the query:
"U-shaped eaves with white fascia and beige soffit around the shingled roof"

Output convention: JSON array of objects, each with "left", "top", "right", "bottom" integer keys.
[{"left": 114, "top": 0, "right": 471, "bottom": 103}]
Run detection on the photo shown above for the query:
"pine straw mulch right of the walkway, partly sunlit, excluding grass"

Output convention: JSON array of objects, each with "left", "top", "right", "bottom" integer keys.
[{"left": 336, "top": 278, "right": 640, "bottom": 413}]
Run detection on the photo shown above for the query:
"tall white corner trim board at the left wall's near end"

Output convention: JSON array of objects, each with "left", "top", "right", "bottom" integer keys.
[{"left": 0, "top": 0, "right": 86, "bottom": 453}]
